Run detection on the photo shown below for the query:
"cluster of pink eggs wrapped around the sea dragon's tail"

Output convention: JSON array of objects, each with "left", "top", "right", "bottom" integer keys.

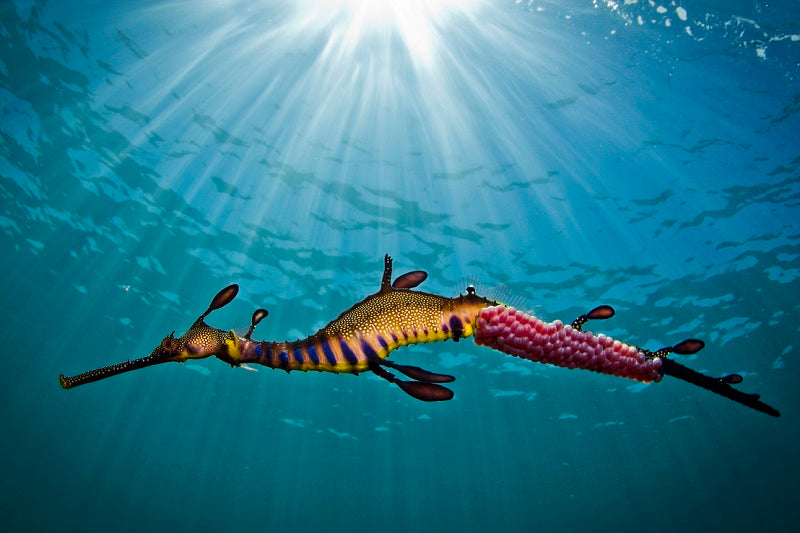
[{"left": 475, "top": 306, "right": 662, "bottom": 383}]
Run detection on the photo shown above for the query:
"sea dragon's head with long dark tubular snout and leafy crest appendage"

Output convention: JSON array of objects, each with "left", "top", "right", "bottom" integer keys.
[{"left": 59, "top": 284, "right": 241, "bottom": 389}]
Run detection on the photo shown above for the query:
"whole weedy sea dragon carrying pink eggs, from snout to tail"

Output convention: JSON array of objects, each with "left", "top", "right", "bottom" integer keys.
[{"left": 59, "top": 255, "right": 780, "bottom": 417}]
